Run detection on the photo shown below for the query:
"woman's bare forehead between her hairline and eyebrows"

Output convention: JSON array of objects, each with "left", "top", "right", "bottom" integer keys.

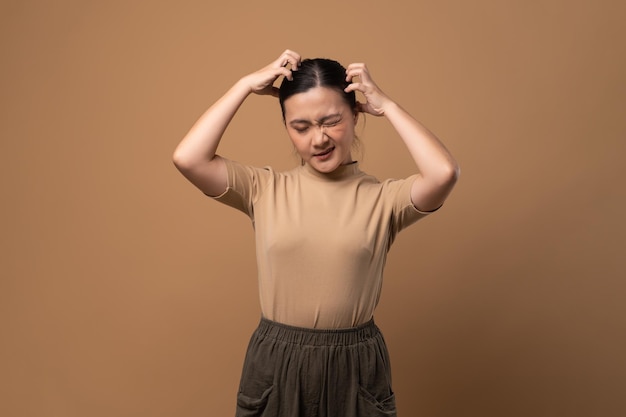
[{"left": 284, "top": 87, "right": 350, "bottom": 121}]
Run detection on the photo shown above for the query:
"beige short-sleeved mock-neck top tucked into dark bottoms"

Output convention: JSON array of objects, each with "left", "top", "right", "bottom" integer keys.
[{"left": 215, "top": 159, "right": 428, "bottom": 329}]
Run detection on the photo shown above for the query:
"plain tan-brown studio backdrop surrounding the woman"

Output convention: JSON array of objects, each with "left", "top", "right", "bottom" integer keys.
[{"left": 0, "top": 0, "right": 626, "bottom": 417}]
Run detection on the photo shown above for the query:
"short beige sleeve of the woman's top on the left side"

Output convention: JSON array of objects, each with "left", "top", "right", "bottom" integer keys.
[{"left": 211, "top": 158, "right": 271, "bottom": 220}]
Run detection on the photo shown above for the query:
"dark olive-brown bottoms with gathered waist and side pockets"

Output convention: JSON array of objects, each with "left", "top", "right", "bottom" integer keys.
[{"left": 236, "top": 319, "right": 396, "bottom": 417}]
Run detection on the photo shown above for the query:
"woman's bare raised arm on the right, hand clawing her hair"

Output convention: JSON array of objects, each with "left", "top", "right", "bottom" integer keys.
[{"left": 346, "top": 64, "right": 459, "bottom": 211}]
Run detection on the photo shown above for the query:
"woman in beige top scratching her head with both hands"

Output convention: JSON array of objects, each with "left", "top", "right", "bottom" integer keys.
[{"left": 174, "top": 50, "right": 459, "bottom": 417}]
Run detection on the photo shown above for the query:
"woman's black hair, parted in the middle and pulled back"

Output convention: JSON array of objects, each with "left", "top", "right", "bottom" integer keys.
[{"left": 278, "top": 58, "right": 357, "bottom": 120}]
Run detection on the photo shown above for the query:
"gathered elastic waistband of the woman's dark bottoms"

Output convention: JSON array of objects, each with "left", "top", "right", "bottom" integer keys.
[{"left": 255, "top": 318, "right": 380, "bottom": 346}]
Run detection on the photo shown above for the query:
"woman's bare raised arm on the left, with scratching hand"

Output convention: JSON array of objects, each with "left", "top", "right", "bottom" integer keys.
[{"left": 173, "top": 50, "right": 300, "bottom": 196}]
